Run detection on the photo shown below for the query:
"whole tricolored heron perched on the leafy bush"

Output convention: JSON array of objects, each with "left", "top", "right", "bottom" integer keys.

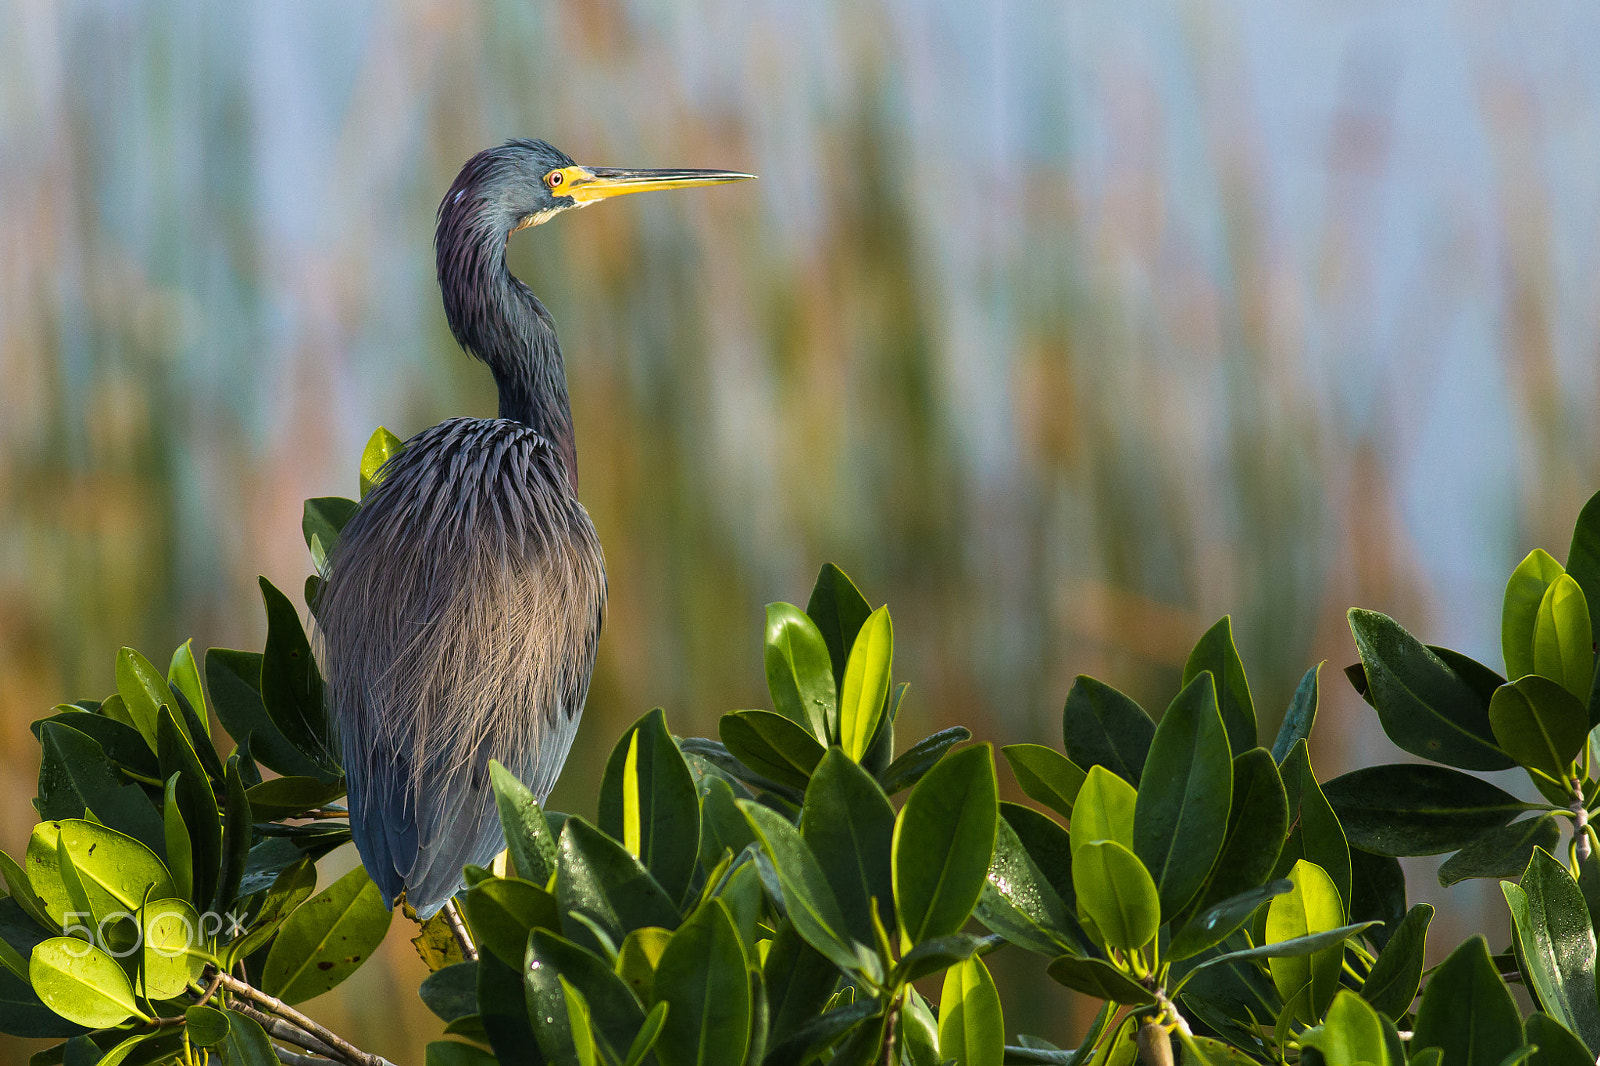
[{"left": 317, "top": 141, "right": 752, "bottom": 919}]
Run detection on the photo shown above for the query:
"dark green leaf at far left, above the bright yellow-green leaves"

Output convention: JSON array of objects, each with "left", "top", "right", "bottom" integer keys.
[{"left": 38, "top": 722, "right": 166, "bottom": 855}]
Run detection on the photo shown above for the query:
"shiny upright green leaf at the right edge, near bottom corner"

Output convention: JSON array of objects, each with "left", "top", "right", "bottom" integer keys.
[{"left": 1501, "top": 848, "right": 1600, "bottom": 1047}]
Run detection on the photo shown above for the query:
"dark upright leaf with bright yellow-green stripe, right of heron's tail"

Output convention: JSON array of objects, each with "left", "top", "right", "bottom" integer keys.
[{"left": 600, "top": 707, "right": 699, "bottom": 896}]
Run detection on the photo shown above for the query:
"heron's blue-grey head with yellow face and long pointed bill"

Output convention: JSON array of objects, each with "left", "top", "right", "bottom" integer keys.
[{"left": 438, "top": 141, "right": 755, "bottom": 235}]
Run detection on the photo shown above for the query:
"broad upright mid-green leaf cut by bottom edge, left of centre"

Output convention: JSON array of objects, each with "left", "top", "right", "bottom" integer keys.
[{"left": 653, "top": 900, "right": 750, "bottom": 1066}]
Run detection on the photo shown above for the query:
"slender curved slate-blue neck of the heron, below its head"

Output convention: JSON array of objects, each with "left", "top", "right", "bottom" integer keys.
[{"left": 437, "top": 208, "right": 578, "bottom": 495}]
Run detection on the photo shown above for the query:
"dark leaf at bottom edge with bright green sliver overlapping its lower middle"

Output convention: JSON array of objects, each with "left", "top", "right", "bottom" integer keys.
[{"left": 523, "top": 928, "right": 646, "bottom": 1063}]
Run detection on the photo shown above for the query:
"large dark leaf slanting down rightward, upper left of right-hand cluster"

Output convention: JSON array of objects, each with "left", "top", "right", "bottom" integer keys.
[{"left": 1350, "top": 608, "right": 1514, "bottom": 770}]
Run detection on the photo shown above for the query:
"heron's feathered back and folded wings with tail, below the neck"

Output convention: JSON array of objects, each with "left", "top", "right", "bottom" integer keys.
[{"left": 318, "top": 419, "right": 605, "bottom": 916}]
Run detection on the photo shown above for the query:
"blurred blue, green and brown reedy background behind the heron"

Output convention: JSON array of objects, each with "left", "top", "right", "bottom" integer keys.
[{"left": 0, "top": 0, "right": 1600, "bottom": 1063}]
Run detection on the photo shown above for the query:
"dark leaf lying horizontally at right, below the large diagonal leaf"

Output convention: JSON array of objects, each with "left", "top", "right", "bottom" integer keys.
[{"left": 1323, "top": 763, "right": 1528, "bottom": 855}]
